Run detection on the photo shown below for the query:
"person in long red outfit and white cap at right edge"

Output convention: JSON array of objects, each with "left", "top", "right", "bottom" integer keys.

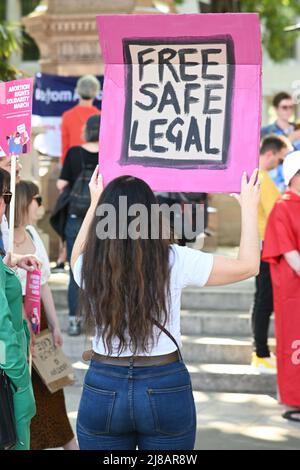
[{"left": 263, "top": 151, "right": 300, "bottom": 422}]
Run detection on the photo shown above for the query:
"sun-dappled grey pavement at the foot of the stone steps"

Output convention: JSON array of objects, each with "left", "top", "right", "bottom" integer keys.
[{"left": 65, "top": 385, "right": 300, "bottom": 450}]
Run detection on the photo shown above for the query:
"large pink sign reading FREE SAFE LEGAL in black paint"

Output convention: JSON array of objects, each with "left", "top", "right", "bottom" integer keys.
[{"left": 97, "top": 13, "right": 261, "bottom": 192}]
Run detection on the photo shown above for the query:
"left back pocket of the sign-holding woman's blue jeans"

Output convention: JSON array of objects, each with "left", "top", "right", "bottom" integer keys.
[{"left": 77, "top": 384, "right": 116, "bottom": 434}]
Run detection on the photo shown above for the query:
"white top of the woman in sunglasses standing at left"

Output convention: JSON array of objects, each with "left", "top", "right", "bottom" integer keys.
[{"left": 16, "top": 225, "right": 51, "bottom": 295}]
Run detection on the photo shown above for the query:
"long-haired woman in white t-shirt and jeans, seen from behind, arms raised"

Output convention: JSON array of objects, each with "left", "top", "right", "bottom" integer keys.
[{"left": 71, "top": 168, "right": 259, "bottom": 450}]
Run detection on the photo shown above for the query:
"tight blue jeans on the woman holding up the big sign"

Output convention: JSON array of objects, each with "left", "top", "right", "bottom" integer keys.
[{"left": 77, "top": 361, "right": 196, "bottom": 450}]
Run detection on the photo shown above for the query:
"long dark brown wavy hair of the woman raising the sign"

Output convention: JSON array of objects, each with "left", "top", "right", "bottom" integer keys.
[{"left": 81, "top": 176, "right": 170, "bottom": 354}]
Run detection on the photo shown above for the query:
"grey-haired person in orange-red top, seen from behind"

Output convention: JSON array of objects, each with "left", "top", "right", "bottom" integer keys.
[{"left": 60, "top": 75, "right": 100, "bottom": 165}]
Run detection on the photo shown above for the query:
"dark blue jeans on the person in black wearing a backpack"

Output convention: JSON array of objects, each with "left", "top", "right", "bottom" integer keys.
[{"left": 65, "top": 215, "right": 82, "bottom": 318}]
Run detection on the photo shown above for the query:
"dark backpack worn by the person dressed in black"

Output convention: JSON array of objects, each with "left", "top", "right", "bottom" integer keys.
[{"left": 69, "top": 149, "right": 97, "bottom": 218}]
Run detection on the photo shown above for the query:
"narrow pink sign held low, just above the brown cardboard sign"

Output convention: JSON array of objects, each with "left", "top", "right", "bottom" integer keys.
[{"left": 24, "top": 269, "right": 41, "bottom": 334}]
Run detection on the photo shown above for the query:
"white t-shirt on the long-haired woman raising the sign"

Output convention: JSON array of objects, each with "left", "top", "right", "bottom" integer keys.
[{"left": 73, "top": 245, "right": 213, "bottom": 356}]
